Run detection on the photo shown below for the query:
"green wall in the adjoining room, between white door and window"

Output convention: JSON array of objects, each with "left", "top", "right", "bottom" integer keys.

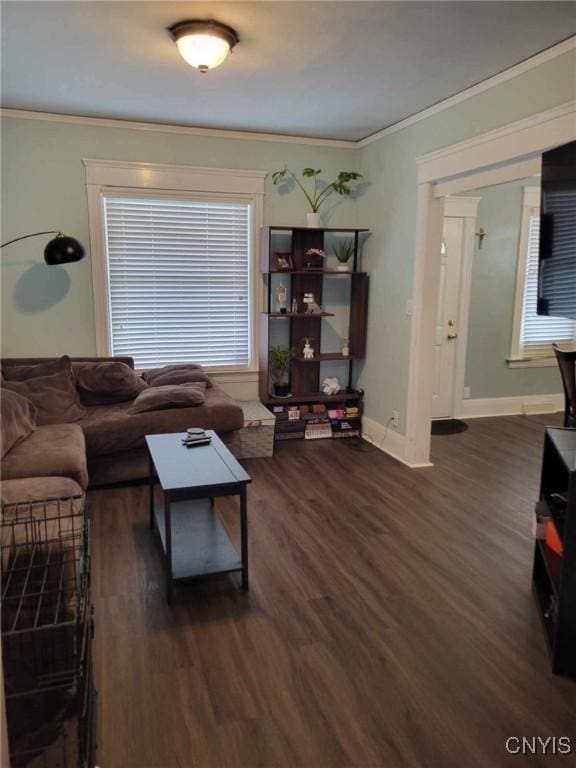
[{"left": 465, "top": 179, "right": 562, "bottom": 398}]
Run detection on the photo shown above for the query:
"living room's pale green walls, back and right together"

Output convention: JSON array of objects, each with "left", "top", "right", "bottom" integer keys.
[{"left": 2, "top": 48, "right": 576, "bottom": 416}]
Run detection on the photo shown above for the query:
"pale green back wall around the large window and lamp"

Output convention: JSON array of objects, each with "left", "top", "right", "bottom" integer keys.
[{"left": 1, "top": 118, "right": 359, "bottom": 356}]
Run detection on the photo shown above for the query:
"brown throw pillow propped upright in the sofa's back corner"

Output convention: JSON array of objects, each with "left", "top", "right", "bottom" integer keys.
[{"left": 3, "top": 370, "right": 86, "bottom": 426}]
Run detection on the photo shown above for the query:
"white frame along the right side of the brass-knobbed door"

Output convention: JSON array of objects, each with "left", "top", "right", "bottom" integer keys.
[{"left": 444, "top": 197, "right": 482, "bottom": 416}]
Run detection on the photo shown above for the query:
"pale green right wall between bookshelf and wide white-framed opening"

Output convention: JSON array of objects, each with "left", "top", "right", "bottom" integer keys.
[{"left": 358, "top": 52, "right": 576, "bottom": 433}]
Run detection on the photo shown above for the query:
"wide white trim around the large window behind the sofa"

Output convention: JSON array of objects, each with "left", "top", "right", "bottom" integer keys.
[{"left": 82, "top": 159, "right": 266, "bottom": 380}]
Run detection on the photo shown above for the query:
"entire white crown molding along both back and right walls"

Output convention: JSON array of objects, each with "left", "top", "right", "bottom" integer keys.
[{"left": 0, "top": 35, "right": 576, "bottom": 149}]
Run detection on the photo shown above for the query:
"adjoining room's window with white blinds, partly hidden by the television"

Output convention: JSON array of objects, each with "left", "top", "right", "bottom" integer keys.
[{"left": 510, "top": 187, "right": 576, "bottom": 364}]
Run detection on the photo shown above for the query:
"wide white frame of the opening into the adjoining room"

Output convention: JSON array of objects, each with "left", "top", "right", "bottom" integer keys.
[{"left": 405, "top": 101, "right": 576, "bottom": 467}]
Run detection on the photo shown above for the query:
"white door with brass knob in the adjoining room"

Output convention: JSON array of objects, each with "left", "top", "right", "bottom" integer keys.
[{"left": 432, "top": 216, "right": 464, "bottom": 419}]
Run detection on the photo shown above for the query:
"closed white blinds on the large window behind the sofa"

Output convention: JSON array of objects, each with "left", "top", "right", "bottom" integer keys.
[{"left": 104, "top": 197, "right": 250, "bottom": 368}]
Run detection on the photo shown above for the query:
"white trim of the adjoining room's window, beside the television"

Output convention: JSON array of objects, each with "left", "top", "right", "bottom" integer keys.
[{"left": 507, "top": 187, "right": 556, "bottom": 368}]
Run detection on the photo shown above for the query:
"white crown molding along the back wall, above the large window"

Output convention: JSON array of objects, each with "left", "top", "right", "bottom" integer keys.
[{"left": 0, "top": 107, "right": 357, "bottom": 149}]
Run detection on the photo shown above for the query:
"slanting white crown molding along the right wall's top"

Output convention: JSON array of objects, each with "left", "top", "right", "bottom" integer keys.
[{"left": 356, "top": 36, "right": 576, "bottom": 148}]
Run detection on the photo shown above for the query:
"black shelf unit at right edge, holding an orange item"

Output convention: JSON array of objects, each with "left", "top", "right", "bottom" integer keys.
[{"left": 532, "top": 427, "right": 576, "bottom": 675}]
